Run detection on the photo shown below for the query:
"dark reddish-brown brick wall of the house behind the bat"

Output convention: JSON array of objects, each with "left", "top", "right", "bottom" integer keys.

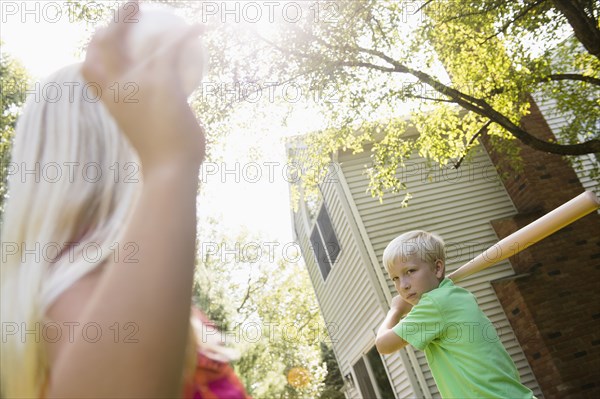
[{"left": 482, "top": 102, "right": 600, "bottom": 398}]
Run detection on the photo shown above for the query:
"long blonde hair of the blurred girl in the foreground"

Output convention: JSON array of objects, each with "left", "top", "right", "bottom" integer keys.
[{"left": 0, "top": 64, "right": 142, "bottom": 398}]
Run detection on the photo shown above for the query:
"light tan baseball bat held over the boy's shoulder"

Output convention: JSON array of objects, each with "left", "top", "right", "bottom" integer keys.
[{"left": 448, "top": 191, "right": 600, "bottom": 283}]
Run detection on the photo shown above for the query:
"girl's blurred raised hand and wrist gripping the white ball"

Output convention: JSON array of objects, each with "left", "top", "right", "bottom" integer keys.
[{"left": 82, "top": 1, "right": 205, "bottom": 173}]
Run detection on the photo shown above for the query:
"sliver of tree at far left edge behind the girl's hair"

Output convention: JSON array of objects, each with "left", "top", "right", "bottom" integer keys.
[{"left": 0, "top": 42, "right": 30, "bottom": 217}]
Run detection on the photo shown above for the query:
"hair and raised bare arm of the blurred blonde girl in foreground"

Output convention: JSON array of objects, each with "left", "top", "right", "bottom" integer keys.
[{"left": 0, "top": 4, "right": 248, "bottom": 399}]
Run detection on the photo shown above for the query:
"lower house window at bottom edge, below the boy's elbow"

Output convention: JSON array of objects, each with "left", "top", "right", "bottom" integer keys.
[{"left": 352, "top": 347, "right": 395, "bottom": 399}]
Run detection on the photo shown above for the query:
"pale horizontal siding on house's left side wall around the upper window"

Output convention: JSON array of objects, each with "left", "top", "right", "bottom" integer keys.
[{"left": 294, "top": 180, "right": 412, "bottom": 397}]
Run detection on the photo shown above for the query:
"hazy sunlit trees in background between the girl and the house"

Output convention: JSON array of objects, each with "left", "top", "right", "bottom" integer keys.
[{"left": 194, "top": 222, "right": 339, "bottom": 398}]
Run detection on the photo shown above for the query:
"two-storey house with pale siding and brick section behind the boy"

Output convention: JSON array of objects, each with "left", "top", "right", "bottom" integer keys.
[{"left": 288, "top": 102, "right": 600, "bottom": 398}]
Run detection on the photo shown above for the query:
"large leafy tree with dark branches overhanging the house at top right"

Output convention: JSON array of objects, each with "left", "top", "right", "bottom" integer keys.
[{"left": 188, "top": 0, "right": 600, "bottom": 202}]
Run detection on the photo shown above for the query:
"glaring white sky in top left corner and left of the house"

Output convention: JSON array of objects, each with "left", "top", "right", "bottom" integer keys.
[{"left": 0, "top": 1, "right": 328, "bottom": 245}]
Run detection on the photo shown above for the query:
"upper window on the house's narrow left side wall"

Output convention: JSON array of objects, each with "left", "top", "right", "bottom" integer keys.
[{"left": 310, "top": 204, "right": 340, "bottom": 280}]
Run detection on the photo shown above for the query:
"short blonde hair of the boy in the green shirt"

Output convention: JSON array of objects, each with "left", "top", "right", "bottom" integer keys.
[{"left": 383, "top": 230, "right": 446, "bottom": 272}]
